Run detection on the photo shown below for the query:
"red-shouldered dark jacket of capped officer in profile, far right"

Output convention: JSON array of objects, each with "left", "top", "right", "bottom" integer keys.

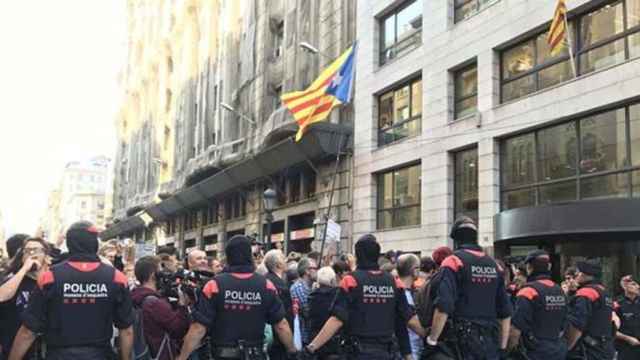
[{"left": 569, "top": 282, "right": 613, "bottom": 340}]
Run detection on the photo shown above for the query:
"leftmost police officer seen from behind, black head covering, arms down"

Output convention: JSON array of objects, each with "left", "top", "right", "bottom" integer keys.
[{"left": 9, "top": 221, "right": 133, "bottom": 360}]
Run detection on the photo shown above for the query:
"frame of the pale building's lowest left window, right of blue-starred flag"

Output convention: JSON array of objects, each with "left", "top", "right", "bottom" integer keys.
[{"left": 375, "top": 162, "right": 422, "bottom": 230}]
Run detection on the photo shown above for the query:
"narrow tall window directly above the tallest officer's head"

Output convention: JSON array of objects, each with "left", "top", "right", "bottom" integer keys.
[{"left": 454, "top": 149, "right": 478, "bottom": 223}]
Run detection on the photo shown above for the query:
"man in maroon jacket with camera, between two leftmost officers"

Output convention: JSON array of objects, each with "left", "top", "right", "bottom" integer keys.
[{"left": 131, "top": 256, "right": 189, "bottom": 360}]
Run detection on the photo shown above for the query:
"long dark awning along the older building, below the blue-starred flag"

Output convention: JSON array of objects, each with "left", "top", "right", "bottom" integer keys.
[{"left": 102, "top": 123, "right": 352, "bottom": 239}]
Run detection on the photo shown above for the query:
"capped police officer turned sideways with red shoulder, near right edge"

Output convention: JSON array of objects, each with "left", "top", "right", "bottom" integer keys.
[{"left": 567, "top": 261, "right": 615, "bottom": 360}]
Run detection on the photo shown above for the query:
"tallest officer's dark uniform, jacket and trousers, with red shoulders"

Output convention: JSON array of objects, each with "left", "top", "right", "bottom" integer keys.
[{"left": 435, "top": 244, "right": 512, "bottom": 360}]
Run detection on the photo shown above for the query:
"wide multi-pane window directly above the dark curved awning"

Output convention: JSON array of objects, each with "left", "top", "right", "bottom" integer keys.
[{"left": 500, "top": 104, "right": 640, "bottom": 210}]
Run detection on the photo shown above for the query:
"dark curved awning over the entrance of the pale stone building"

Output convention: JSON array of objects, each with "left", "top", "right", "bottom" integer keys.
[{"left": 495, "top": 199, "right": 640, "bottom": 241}]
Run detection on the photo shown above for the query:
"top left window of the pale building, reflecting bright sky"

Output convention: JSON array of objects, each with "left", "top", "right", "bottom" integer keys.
[{"left": 380, "top": 1, "right": 422, "bottom": 65}]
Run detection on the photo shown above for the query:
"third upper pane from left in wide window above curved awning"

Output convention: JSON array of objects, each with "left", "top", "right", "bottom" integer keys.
[{"left": 580, "top": 108, "right": 627, "bottom": 174}]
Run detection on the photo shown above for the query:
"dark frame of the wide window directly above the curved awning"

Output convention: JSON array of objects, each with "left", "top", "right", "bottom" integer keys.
[{"left": 500, "top": 101, "right": 640, "bottom": 211}]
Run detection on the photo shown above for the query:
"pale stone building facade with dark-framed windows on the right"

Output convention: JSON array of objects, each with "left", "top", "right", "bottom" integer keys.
[{"left": 353, "top": 0, "right": 640, "bottom": 279}]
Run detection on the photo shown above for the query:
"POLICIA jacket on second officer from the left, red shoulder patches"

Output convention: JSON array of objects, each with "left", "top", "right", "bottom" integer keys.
[{"left": 192, "top": 270, "right": 285, "bottom": 347}]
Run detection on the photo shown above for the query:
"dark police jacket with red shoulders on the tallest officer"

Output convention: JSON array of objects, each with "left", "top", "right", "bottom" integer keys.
[{"left": 434, "top": 245, "right": 512, "bottom": 322}]
